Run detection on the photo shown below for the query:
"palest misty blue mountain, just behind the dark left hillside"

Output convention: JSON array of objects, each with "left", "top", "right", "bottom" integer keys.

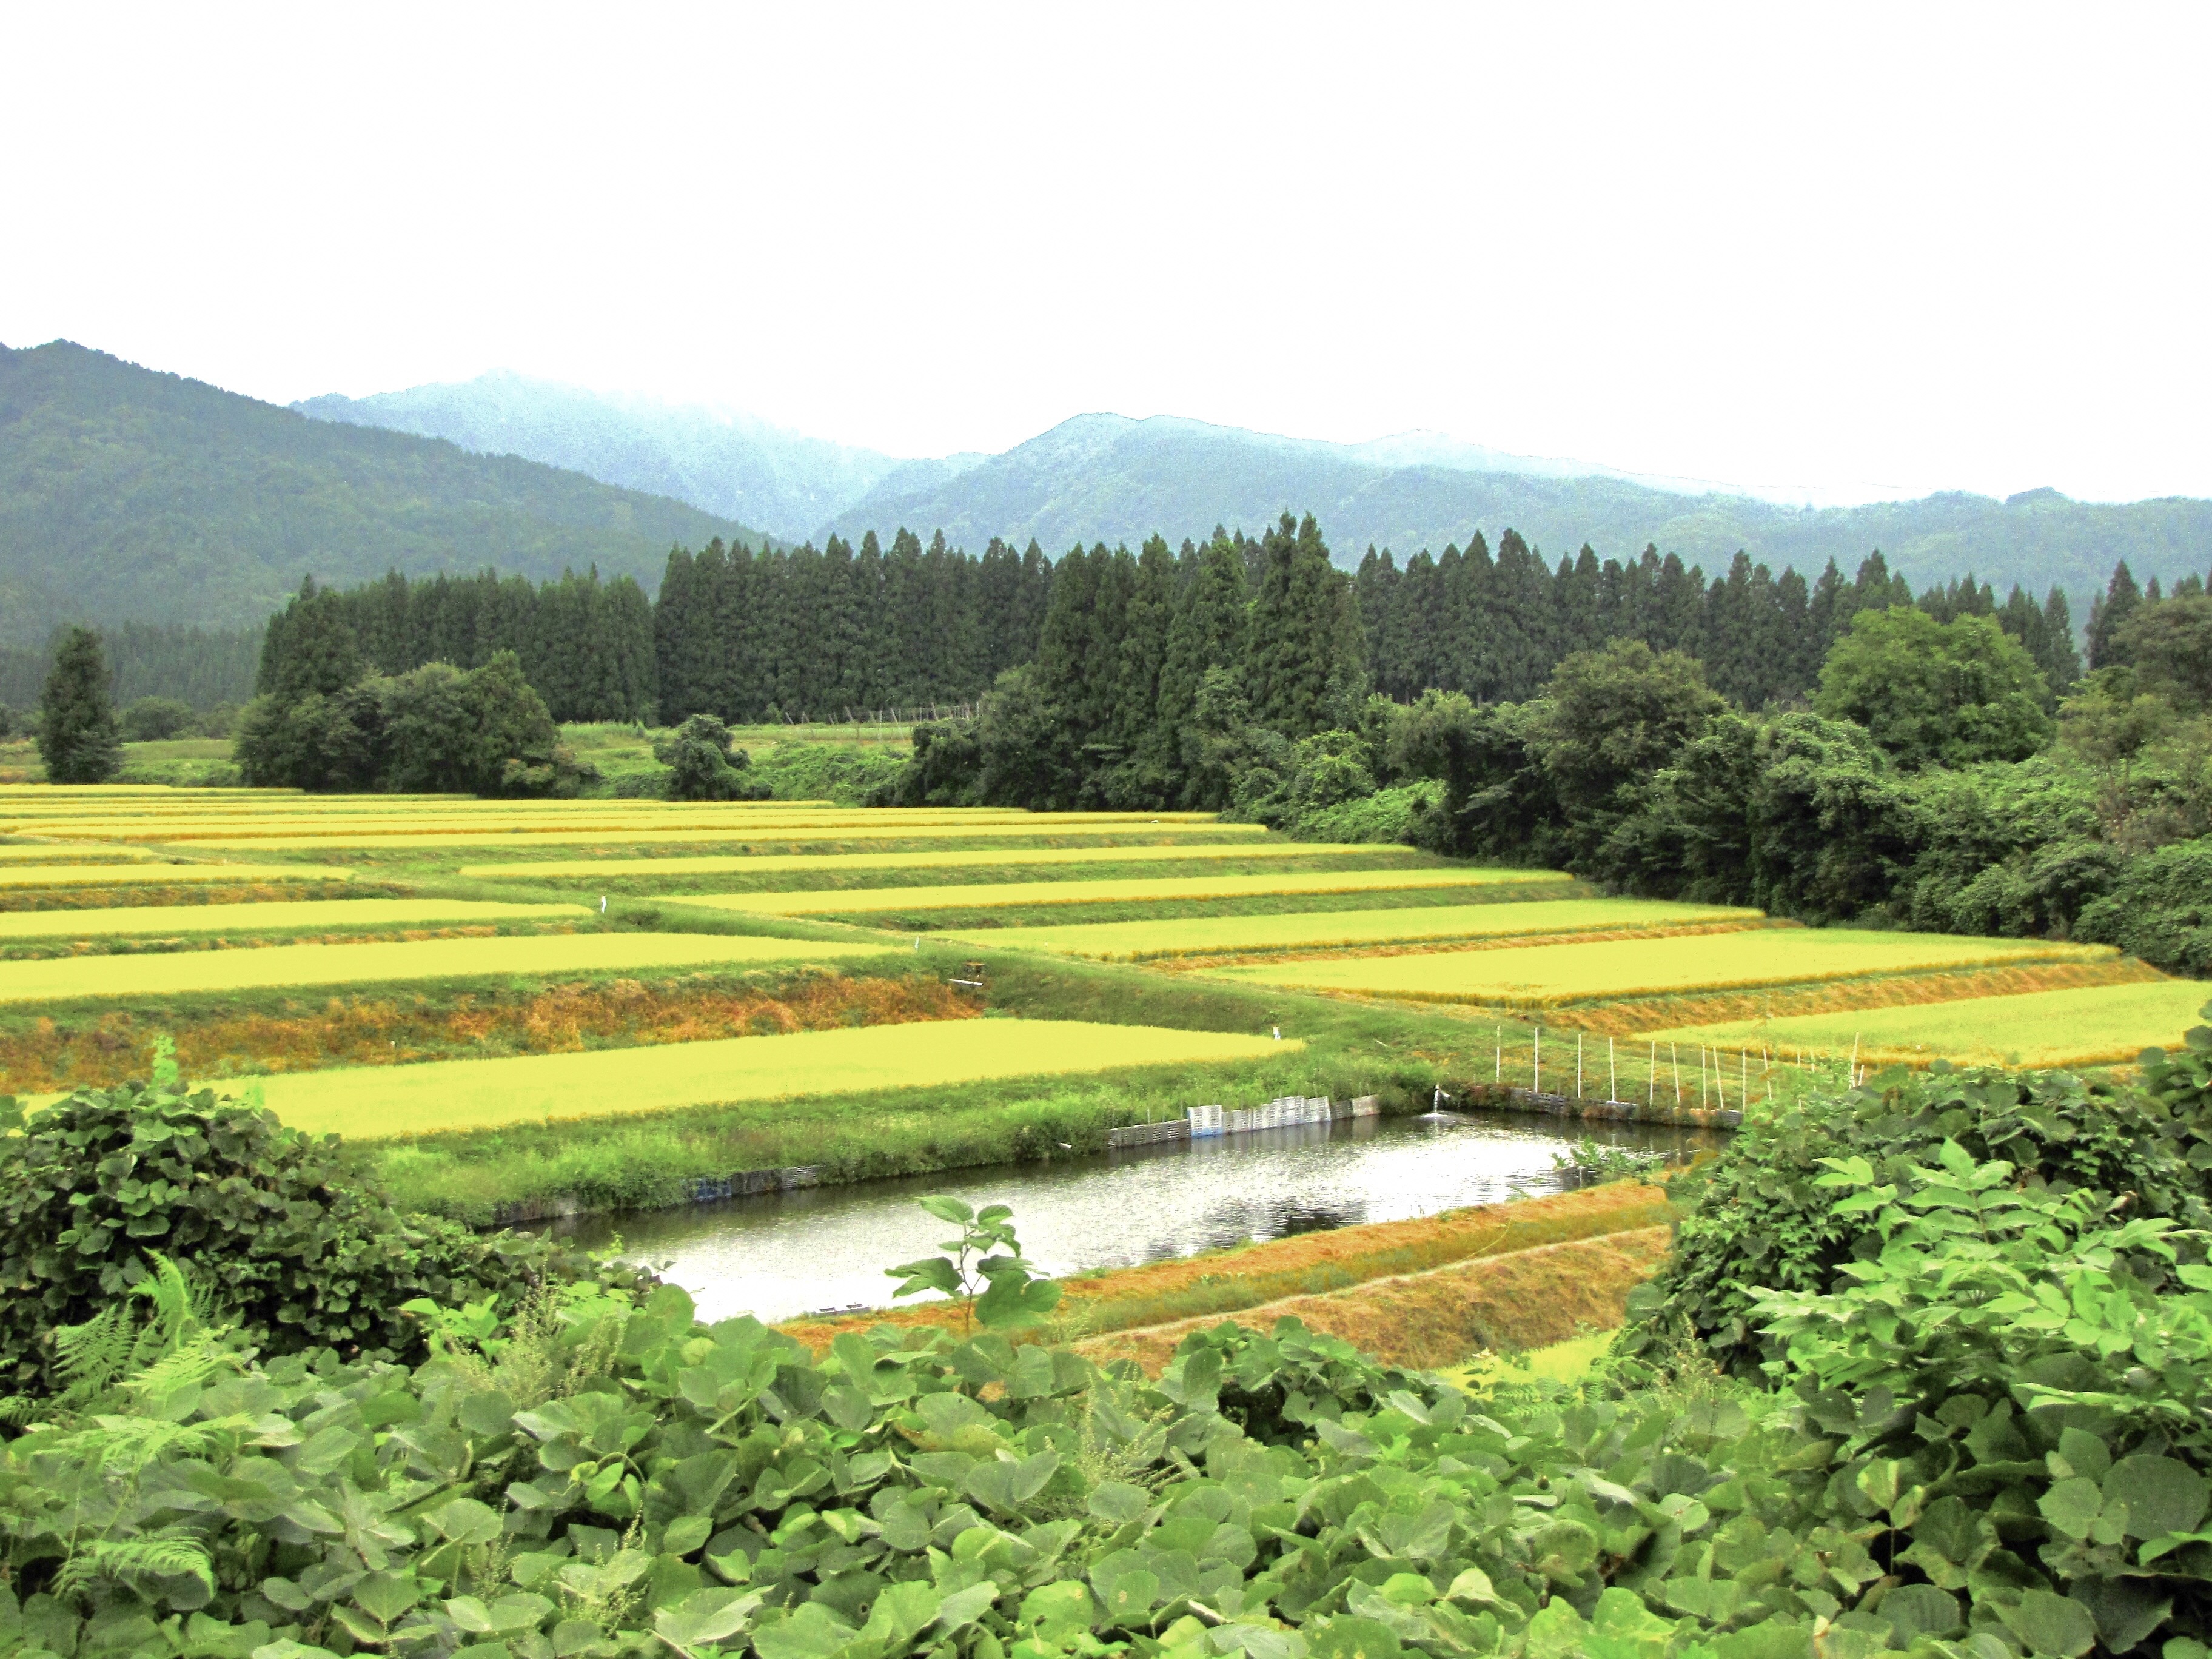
[{"left": 292, "top": 369, "right": 982, "bottom": 542}]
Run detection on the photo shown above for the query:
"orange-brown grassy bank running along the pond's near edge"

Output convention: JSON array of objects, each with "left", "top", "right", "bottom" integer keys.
[{"left": 783, "top": 1181, "right": 1675, "bottom": 1358}]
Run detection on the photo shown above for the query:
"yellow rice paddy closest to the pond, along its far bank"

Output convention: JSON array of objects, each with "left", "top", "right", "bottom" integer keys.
[{"left": 242, "top": 1020, "right": 1294, "bottom": 1139}]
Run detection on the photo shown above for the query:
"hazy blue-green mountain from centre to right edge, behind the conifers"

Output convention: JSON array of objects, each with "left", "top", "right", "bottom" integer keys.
[{"left": 825, "top": 414, "right": 2212, "bottom": 597}]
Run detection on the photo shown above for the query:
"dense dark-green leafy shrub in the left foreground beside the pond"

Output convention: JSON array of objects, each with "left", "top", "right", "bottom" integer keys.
[{"left": 0, "top": 1073, "right": 579, "bottom": 1393}]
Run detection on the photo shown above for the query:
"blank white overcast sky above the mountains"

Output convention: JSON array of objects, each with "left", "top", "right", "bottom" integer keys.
[{"left": 0, "top": 0, "right": 2212, "bottom": 500}]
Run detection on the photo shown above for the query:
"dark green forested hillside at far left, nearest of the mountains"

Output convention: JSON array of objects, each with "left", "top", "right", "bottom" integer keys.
[{"left": 0, "top": 341, "right": 757, "bottom": 648}]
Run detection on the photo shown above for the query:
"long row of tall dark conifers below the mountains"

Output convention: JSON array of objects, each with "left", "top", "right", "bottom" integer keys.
[{"left": 261, "top": 513, "right": 2105, "bottom": 734}]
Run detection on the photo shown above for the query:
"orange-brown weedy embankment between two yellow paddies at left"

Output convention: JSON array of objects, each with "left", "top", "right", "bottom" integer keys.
[{"left": 0, "top": 965, "right": 982, "bottom": 1095}]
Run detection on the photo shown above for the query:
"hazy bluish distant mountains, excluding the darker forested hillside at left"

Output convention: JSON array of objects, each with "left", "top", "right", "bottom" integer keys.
[{"left": 292, "top": 374, "right": 2212, "bottom": 611}]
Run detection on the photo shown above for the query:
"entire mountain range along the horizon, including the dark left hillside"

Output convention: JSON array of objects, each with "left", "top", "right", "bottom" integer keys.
[{"left": 0, "top": 341, "right": 2212, "bottom": 648}]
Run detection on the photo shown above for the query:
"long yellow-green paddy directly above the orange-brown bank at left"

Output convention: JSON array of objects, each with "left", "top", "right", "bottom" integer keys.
[{"left": 0, "top": 933, "right": 885, "bottom": 1004}]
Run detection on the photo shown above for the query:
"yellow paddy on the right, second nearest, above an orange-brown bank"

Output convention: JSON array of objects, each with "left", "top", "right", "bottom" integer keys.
[{"left": 1210, "top": 927, "right": 2119, "bottom": 1011}]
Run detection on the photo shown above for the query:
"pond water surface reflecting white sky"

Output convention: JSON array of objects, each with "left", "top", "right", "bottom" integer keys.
[{"left": 557, "top": 1113, "right": 1708, "bottom": 1318}]
